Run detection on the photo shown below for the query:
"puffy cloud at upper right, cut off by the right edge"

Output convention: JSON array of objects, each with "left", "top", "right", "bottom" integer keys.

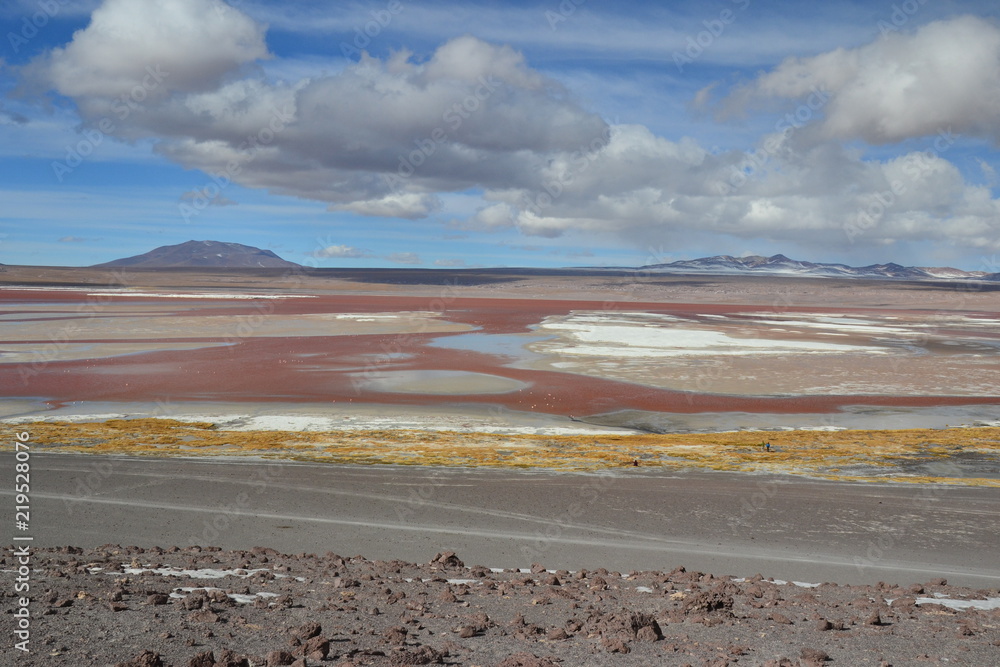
[{"left": 727, "top": 16, "right": 1000, "bottom": 144}]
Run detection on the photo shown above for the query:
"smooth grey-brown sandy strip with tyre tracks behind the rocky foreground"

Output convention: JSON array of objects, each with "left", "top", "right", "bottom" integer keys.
[{"left": 15, "top": 454, "right": 1000, "bottom": 587}]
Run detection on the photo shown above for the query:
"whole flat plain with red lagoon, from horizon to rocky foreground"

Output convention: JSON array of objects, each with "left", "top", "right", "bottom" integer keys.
[{"left": 0, "top": 267, "right": 1000, "bottom": 664}]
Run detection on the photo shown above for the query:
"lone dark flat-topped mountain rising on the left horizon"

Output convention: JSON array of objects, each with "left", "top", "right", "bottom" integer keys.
[{"left": 95, "top": 241, "right": 300, "bottom": 269}]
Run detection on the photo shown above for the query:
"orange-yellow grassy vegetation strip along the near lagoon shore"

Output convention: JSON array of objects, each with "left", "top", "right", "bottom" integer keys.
[{"left": 18, "top": 418, "right": 1000, "bottom": 487}]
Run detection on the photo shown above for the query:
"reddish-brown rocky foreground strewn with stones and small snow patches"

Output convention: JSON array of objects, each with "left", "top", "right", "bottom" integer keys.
[{"left": 0, "top": 545, "right": 1000, "bottom": 667}]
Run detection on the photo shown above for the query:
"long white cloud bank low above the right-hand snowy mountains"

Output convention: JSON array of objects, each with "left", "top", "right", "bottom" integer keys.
[{"left": 474, "top": 121, "right": 1000, "bottom": 250}]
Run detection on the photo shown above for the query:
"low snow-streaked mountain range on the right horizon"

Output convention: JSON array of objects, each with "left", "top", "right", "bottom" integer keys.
[{"left": 640, "top": 255, "right": 1000, "bottom": 280}]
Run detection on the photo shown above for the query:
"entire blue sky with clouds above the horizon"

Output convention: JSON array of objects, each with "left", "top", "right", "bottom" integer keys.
[{"left": 0, "top": 0, "right": 1000, "bottom": 272}]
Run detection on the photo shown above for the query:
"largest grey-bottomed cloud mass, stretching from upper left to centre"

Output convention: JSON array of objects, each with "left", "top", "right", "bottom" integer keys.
[{"left": 26, "top": 0, "right": 606, "bottom": 219}]
